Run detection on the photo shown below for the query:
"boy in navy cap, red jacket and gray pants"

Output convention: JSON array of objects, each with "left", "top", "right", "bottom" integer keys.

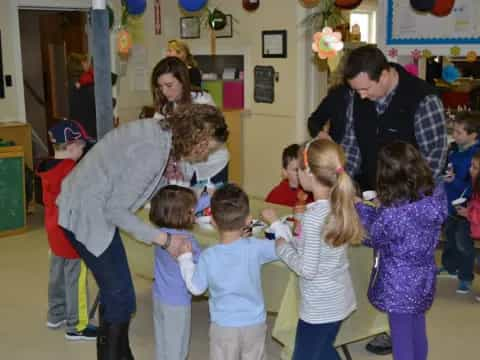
[{"left": 38, "top": 120, "right": 97, "bottom": 340}]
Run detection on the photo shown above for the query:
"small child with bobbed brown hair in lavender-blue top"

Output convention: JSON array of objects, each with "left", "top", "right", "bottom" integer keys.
[{"left": 150, "top": 185, "right": 200, "bottom": 360}]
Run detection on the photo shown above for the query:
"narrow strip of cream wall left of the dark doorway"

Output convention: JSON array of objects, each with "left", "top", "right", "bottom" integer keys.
[{"left": 0, "top": 0, "right": 20, "bottom": 122}]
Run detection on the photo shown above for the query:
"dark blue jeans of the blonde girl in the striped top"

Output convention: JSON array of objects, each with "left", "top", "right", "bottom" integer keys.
[{"left": 292, "top": 320, "right": 342, "bottom": 360}]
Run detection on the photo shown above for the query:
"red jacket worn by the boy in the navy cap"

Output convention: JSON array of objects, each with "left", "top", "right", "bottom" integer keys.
[{"left": 38, "top": 159, "right": 79, "bottom": 259}]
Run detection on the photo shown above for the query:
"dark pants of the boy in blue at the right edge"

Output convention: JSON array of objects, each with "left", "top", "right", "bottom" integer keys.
[{"left": 442, "top": 216, "right": 475, "bottom": 281}]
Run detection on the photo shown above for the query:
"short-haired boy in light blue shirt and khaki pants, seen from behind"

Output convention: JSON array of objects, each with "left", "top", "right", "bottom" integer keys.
[{"left": 178, "top": 184, "right": 277, "bottom": 360}]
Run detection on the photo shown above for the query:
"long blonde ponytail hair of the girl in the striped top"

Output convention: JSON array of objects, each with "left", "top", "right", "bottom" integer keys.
[{"left": 300, "top": 139, "right": 365, "bottom": 247}]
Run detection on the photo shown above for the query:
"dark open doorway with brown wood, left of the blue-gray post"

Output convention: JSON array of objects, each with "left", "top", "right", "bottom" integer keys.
[{"left": 19, "top": 9, "right": 88, "bottom": 158}]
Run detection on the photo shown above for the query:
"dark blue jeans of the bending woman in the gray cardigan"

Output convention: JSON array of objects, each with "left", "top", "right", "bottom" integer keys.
[{"left": 64, "top": 229, "right": 136, "bottom": 324}]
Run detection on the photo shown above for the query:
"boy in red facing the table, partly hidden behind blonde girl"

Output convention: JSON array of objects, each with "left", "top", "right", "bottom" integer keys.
[{"left": 265, "top": 144, "right": 313, "bottom": 207}]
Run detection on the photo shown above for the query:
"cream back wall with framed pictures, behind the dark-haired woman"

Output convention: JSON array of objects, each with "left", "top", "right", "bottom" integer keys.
[{"left": 116, "top": 0, "right": 310, "bottom": 197}]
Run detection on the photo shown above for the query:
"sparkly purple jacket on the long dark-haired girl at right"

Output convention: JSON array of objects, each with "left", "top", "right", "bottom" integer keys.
[{"left": 357, "top": 185, "right": 447, "bottom": 314}]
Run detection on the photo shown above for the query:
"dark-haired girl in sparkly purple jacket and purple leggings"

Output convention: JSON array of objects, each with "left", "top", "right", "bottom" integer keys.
[{"left": 357, "top": 142, "right": 447, "bottom": 360}]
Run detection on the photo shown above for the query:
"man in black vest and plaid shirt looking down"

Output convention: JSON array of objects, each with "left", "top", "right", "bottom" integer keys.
[{"left": 342, "top": 45, "right": 447, "bottom": 355}]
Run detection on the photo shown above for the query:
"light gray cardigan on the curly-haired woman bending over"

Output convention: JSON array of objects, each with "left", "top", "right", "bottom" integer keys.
[{"left": 57, "top": 119, "right": 193, "bottom": 256}]
